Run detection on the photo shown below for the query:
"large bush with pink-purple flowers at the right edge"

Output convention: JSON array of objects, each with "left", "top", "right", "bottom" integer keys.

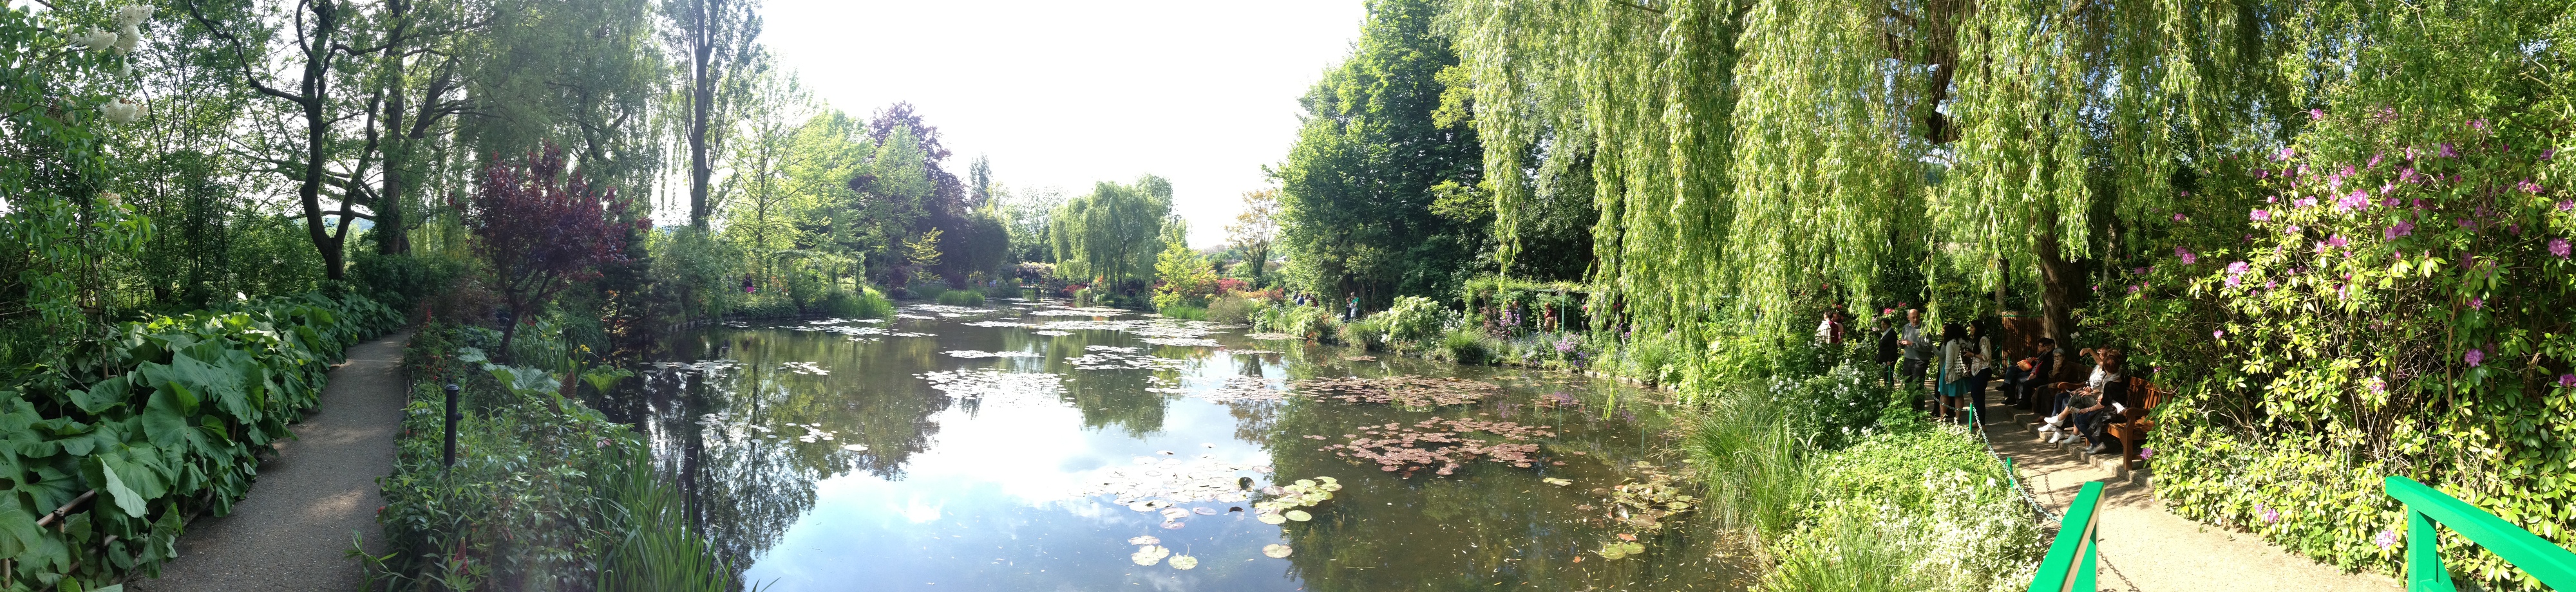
[{"left": 2092, "top": 113, "right": 2576, "bottom": 587}]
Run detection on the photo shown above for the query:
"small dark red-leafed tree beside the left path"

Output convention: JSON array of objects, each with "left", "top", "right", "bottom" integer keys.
[{"left": 461, "top": 144, "right": 652, "bottom": 358}]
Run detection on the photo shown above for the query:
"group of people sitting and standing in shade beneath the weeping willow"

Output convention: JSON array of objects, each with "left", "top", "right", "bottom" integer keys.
[{"left": 1865, "top": 309, "right": 2130, "bottom": 453}]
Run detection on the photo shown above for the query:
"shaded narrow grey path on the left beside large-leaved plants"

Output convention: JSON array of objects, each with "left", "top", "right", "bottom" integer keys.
[{"left": 126, "top": 332, "right": 412, "bottom": 592}]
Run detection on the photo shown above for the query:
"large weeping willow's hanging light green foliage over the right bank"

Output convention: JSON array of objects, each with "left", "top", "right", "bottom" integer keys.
[{"left": 1448, "top": 0, "right": 2285, "bottom": 363}]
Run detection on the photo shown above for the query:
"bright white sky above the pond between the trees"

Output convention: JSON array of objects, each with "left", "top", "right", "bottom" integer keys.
[{"left": 760, "top": 0, "right": 1365, "bottom": 247}]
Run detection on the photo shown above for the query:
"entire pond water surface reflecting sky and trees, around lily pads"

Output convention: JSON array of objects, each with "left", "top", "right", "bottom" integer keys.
[{"left": 636, "top": 305, "right": 1736, "bottom": 592}]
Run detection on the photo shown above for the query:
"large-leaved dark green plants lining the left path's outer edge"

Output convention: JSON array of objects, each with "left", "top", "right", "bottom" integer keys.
[{"left": 0, "top": 293, "right": 402, "bottom": 589}]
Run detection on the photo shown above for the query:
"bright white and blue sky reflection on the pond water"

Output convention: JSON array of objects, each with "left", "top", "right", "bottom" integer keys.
[{"left": 744, "top": 371, "right": 1298, "bottom": 592}]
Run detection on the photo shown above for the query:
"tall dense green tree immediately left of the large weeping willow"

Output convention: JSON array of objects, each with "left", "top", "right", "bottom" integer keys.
[{"left": 1270, "top": 0, "right": 1489, "bottom": 304}]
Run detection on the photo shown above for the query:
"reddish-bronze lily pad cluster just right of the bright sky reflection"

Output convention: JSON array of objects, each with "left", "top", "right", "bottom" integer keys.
[{"left": 1309, "top": 417, "right": 1556, "bottom": 476}]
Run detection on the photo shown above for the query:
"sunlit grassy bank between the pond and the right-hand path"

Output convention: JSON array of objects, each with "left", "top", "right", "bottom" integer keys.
[{"left": 1687, "top": 363, "right": 2045, "bottom": 592}]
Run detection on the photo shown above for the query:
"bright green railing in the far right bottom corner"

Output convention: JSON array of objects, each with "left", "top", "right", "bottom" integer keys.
[{"left": 2388, "top": 476, "right": 2576, "bottom": 592}]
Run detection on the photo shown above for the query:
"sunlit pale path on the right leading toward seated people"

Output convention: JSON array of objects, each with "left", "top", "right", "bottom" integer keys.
[{"left": 1986, "top": 394, "right": 2403, "bottom": 592}]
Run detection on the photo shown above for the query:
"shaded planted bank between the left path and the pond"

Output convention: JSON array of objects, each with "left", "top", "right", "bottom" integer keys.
[{"left": 366, "top": 324, "right": 734, "bottom": 592}]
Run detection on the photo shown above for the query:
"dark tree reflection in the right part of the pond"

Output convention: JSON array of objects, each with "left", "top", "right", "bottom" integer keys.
[{"left": 1247, "top": 376, "right": 1739, "bottom": 592}]
